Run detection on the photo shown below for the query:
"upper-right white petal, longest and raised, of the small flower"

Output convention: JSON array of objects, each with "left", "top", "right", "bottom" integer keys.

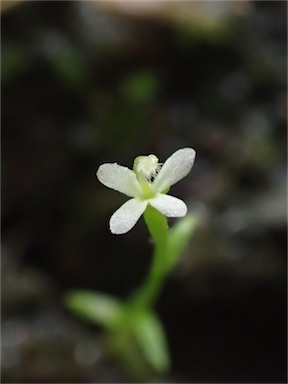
[{"left": 152, "top": 148, "right": 196, "bottom": 192}]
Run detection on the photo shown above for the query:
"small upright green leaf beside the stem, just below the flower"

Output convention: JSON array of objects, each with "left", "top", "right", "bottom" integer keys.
[{"left": 167, "top": 214, "right": 199, "bottom": 270}]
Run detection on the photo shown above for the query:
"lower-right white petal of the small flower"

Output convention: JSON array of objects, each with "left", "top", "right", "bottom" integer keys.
[{"left": 149, "top": 193, "right": 187, "bottom": 217}]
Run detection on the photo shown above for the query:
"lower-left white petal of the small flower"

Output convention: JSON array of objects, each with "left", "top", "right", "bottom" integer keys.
[{"left": 110, "top": 199, "right": 147, "bottom": 235}]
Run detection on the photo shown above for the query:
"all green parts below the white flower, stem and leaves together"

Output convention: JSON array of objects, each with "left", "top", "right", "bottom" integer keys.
[{"left": 64, "top": 205, "right": 198, "bottom": 377}]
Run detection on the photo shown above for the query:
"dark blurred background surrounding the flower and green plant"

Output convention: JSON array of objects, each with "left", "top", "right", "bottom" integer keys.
[{"left": 1, "top": 1, "right": 287, "bottom": 383}]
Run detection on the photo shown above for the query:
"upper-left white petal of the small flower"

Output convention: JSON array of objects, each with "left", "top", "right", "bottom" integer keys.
[{"left": 97, "top": 163, "right": 140, "bottom": 197}]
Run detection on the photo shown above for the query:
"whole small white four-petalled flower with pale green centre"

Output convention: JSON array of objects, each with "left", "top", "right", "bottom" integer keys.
[{"left": 97, "top": 148, "right": 196, "bottom": 235}]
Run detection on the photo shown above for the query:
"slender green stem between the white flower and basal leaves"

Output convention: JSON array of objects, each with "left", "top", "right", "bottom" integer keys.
[{"left": 132, "top": 206, "right": 168, "bottom": 307}]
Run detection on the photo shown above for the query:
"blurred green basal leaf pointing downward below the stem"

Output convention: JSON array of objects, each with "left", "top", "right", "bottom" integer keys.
[{"left": 132, "top": 310, "right": 170, "bottom": 373}]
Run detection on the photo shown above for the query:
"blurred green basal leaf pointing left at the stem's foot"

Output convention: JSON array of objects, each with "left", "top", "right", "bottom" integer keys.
[{"left": 64, "top": 290, "right": 123, "bottom": 329}]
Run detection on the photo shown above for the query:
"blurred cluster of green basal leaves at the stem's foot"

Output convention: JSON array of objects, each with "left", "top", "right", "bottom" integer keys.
[{"left": 64, "top": 290, "right": 170, "bottom": 373}]
